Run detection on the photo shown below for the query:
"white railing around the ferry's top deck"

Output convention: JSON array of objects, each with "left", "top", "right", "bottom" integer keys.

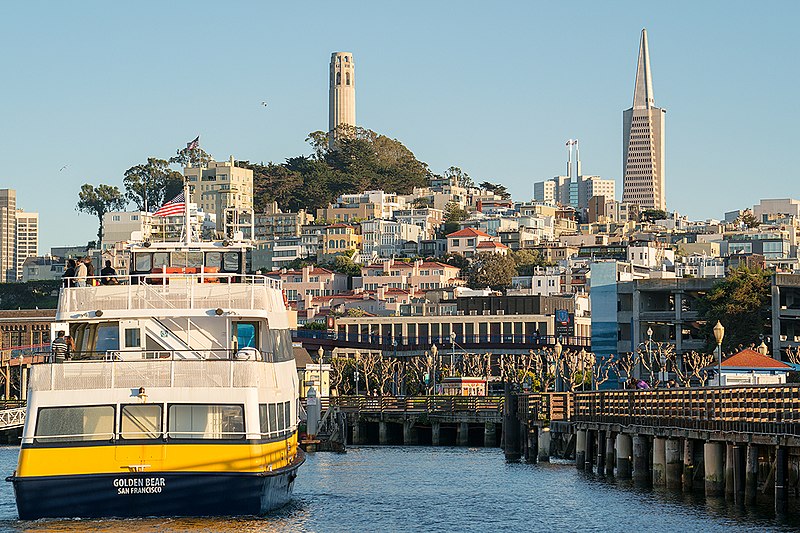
[{"left": 58, "top": 273, "right": 286, "bottom": 316}]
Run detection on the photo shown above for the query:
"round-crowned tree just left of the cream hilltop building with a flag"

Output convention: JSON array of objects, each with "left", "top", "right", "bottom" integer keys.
[{"left": 122, "top": 157, "right": 183, "bottom": 211}]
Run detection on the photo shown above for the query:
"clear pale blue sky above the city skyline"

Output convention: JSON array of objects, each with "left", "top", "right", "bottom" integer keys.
[{"left": 0, "top": 0, "right": 800, "bottom": 253}]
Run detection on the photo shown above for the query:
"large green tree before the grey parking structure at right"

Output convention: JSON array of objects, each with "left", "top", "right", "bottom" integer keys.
[{"left": 699, "top": 264, "right": 771, "bottom": 351}]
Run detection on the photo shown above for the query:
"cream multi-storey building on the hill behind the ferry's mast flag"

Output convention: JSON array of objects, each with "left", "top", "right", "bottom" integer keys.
[{"left": 183, "top": 156, "right": 253, "bottom": 231}]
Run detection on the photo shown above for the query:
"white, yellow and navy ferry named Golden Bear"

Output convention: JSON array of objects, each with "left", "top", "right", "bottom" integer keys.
[{"left": 7, "top": 197, "right": 304, "bottom": 520}]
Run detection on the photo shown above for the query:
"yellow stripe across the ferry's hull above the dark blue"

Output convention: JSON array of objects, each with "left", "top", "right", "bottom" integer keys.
[{"left": 16, "top": 434, "right": 297, "bottom": 477}]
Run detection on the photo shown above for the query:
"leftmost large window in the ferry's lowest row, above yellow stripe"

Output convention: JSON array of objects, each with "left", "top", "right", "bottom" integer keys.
[{"left": 34, "top": 405, "right": 114, "bottom": 443}]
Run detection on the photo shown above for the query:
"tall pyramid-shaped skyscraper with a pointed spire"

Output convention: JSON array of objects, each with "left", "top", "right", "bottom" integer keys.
[{"left": 622, "top": 30, "right": 667, "bottom": 210}]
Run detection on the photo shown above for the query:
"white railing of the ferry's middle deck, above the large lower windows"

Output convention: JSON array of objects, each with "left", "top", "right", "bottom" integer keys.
[{"left": 30, "top": 358, "right": 291, "bottom": 395}]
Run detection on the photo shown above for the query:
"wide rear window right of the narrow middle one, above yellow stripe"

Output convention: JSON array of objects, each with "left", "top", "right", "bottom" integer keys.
[{"left": 168, "top": 404, "right": 245, "bottom": 439}]
